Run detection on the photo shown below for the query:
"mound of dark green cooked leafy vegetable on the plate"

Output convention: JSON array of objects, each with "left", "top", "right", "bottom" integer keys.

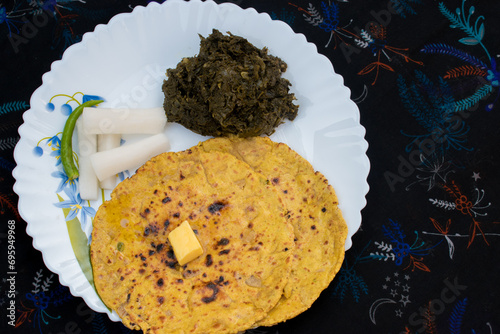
[{"left": 162, "top": 29, "right": 298, "bottom": 137}]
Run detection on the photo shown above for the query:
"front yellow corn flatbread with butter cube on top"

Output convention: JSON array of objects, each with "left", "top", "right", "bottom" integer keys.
[{"left": 91, "top": 148, "right": 295, "bottom": 333}]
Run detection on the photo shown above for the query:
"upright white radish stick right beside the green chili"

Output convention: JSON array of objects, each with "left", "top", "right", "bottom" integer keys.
[{"left": 76, "top": 119, "right": 99, "bottom": 201}]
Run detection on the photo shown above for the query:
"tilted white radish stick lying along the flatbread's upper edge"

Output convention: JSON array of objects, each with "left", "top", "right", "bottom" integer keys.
[{"left": 90, "top": 133, "right": 170, "bottom": 181}]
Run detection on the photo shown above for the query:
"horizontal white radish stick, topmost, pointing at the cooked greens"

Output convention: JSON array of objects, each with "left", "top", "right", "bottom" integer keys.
[{"left": 82, "top": 107, "right": 167, "bottom": 134}]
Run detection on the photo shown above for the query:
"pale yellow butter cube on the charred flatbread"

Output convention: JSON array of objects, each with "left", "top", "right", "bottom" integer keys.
[{"left": 168, "top": 220, "right": 203, "bottom": 266}]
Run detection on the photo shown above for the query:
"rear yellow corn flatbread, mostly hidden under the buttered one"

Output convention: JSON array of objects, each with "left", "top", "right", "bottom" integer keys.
[{"left": 199, "top": 137, "right": 347, "bottom": 326}]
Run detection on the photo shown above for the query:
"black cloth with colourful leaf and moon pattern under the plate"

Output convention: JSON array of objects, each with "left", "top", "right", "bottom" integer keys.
[{"left": 0, "top": 0, "right": 500, "bottom": 334}]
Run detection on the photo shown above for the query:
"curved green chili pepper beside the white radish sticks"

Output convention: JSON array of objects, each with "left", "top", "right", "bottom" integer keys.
[{"left": 61, "top": 100, "right": 103, "bottom": 180}]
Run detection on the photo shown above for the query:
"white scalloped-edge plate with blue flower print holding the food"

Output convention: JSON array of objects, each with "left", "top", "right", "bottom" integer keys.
[{"left": 13, "top": 0, "right": 370, "bottom": 321}]
